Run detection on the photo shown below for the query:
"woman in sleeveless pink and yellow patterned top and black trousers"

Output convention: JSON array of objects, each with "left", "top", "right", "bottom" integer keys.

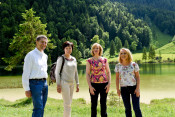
[{"left": 86, "top": 43, "right": 111, "bottom": 117}]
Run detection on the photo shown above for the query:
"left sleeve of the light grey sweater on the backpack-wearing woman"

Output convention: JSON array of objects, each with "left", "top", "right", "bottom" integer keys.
[{"left": 55, "top": 57, "right": 63, "bottom": 85}]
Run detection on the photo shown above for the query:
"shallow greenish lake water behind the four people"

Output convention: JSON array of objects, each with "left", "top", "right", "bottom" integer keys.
[{"left": 0, "top": 64, "right": 175, "bottom": 103}]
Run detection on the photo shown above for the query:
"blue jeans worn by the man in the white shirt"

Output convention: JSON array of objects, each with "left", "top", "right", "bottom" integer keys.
[{"left": 29, "top": 80, "right": 48, "bottom": 117}]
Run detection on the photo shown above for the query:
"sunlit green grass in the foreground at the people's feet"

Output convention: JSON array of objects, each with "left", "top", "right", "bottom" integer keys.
[{"left": 0, "top": 94, "right": 175, "bottom": 117}]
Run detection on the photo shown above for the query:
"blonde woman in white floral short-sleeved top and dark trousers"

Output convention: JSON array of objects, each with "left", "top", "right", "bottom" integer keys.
[{"left": 114, "top": 48, "right": 142, "bottom": 117}]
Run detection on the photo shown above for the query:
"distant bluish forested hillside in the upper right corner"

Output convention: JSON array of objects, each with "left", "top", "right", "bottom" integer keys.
[{"left": 111, "top": 0, "right": 175, "bottom": 36}]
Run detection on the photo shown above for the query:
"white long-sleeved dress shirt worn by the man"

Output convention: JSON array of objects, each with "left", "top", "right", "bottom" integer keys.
[{"left": 22, "top": 48, "right": 48, "bottom": 91}]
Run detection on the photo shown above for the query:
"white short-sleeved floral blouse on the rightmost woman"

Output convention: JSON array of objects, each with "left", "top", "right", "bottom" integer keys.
[{"left": 114, "top": 62, "right": 139, "bottom": 87}]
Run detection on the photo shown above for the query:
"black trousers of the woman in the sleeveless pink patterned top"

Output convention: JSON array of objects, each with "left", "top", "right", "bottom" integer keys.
[{"left": 90, "top": 83, "right": 108, "bottom": 117}]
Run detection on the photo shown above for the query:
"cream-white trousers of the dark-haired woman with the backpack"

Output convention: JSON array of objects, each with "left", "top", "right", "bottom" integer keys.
[{"left": 61, "top": 81, "right": 74, "bottom": 117}]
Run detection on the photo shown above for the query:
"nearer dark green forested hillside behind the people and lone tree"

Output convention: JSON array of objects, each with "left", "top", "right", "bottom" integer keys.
[{"left": 0, "top": 0, "right": 152, "bottom": 65}]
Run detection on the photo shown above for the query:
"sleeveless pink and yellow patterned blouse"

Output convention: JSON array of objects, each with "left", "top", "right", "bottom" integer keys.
[{"left": 87, "top": 58, "right": 108, "bottom": 83}]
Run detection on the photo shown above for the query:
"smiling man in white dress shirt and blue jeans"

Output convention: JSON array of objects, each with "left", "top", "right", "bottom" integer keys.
[{"left": 22, "top": 35, "right": 48, "bottom": 117}]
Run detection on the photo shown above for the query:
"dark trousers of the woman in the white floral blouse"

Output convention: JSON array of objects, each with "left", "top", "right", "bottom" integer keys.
[{"left": 121, "top": 86, "right": 142, "bottom": 117}]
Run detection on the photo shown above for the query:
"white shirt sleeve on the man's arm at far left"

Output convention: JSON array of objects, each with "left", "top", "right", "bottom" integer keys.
[{"left": 22, "top": 54, "right": 32, "bottom": 91}]
